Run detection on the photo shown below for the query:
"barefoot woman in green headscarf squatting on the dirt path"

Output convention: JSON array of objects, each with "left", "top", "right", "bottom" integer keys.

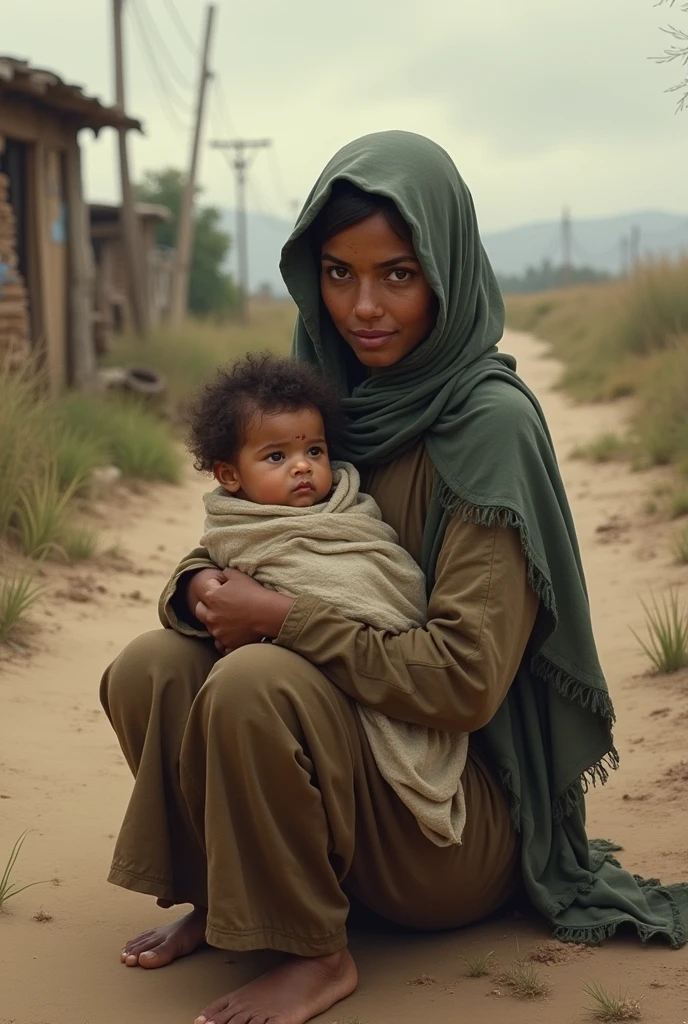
[{"left": 102, "top": 132, "right": 688, "bottom": 1024}]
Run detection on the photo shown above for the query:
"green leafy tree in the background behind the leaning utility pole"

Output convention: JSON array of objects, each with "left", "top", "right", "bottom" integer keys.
[{"left": 136, "top": 167, "right": 238, "bottom": 316}]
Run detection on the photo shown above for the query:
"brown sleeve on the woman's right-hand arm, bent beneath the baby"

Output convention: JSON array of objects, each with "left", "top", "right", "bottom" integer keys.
[{"left": 276, "top": 519, "right": 539, "bottom": 732}]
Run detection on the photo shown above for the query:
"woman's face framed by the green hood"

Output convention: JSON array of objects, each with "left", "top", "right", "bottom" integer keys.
[{"left": 320, "top": 213, "right": 437, "bottom": 370}]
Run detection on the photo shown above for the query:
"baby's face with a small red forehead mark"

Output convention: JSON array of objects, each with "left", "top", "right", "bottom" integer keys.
[{"left": 215, "top": 409, "right": 332, "bottom": 508}]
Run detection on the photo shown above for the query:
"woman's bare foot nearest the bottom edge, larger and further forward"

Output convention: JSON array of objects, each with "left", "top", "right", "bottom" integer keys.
[{"left": 195, "top": 949, "right": 358, "bottom": 1024}]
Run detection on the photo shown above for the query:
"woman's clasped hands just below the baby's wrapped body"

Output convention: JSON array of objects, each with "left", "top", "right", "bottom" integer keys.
[{"left": 188, "top": 569, "right": 295, "bottom": 653}]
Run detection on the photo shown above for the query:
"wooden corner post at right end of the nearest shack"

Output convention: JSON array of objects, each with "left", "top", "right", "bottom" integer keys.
[{"left": 67, "top": 134, "right": 95, "bottom": 388}]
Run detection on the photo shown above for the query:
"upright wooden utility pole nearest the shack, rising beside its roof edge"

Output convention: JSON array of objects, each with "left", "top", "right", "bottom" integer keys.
[{"left": 113, "top": 0, "right": 148, "bottom": 336}]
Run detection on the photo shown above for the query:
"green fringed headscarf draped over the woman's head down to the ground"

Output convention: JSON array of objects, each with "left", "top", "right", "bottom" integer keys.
[{"left": 281, "top": 131, "right": 688, "bottom": 946}]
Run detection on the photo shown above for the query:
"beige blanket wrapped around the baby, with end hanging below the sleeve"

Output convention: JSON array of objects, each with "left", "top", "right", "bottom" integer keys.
[{"left": 201, "top": 463, "right": 468, "bottom": 846}]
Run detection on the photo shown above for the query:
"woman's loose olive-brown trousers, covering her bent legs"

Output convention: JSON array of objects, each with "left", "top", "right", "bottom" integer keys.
[{"left": 101, "top": 629, "right": 519, "bottom": 956}]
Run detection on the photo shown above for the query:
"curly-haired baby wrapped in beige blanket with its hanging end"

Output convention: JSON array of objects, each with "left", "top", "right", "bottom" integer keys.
[{"left": 188, "top": 353, "right": 468, "bottom": 846}]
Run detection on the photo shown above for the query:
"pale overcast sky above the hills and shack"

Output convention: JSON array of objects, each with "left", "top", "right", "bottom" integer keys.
[{"left": 5, "top": 0, "right": 688, "bottom": 230}]
